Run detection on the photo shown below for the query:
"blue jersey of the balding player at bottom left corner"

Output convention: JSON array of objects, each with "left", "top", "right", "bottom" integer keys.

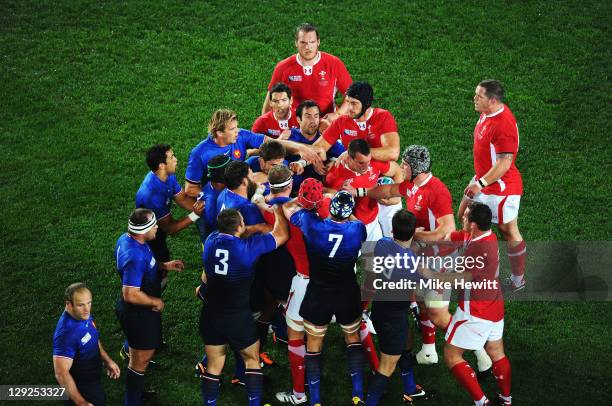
[{"left": 53, "top": 311, "right": 102, "bottom": 383}]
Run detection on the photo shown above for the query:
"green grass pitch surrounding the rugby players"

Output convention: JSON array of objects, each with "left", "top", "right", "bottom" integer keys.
[{"left": 0, "top": 1, "right": 612, "bottom": 405}]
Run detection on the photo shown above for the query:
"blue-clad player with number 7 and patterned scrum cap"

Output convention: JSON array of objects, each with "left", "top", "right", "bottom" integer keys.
[{"left": 283, "top": 191, "right": 366, "bottom": 405}]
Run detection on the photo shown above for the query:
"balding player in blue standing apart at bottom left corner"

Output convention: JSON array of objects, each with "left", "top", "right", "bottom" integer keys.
[{"left": 53, "top": 283, "right": 121, "bottom": 406}]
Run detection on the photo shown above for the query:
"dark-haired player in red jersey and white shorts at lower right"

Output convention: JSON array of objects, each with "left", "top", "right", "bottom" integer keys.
[{"left": 421, "top": 203, "right": 512, "bottom": 406}]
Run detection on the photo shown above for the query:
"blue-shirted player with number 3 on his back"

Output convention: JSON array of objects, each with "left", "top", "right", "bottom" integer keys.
[{"left": 200, "top": 207, "right": 289, "bottom": 406}]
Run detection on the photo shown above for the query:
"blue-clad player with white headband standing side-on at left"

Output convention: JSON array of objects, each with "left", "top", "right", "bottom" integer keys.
[{"left": 115, "top": 208, "right": 184, "bottom": 406}]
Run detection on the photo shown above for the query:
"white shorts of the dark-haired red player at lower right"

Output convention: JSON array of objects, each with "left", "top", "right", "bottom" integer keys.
[{"left": 445, "top": 307, "right": 504, "bottom": 350}]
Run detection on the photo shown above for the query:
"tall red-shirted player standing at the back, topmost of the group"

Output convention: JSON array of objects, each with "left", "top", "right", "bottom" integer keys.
[{"left": 261, "top": 23, "right": 352, "bottom": 121}]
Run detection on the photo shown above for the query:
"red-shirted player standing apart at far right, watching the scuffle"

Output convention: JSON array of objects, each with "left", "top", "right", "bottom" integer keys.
[{"left": 459, "top": 80, "right": 527, "bottom": 291}]
